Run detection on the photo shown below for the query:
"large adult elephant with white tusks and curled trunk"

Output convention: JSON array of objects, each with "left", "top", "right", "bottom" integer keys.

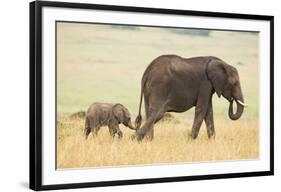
[{"left": 133, "top": 55, "right": 246, "bottom": 141}]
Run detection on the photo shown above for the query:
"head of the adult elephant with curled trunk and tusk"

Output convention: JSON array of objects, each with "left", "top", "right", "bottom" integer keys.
[{"left": 206, "top": 58, "right": 246, "bottom": 120}]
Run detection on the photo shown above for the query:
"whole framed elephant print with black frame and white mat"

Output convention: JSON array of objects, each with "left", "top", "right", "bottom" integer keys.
[{"left": 30, "top": 1, "right": 274, "bottom": 190}]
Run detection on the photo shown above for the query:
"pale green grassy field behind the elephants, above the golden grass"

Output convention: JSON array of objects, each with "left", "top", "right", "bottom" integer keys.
[{"left": 57, "top": 23, "right": 258, "bottom": 118}]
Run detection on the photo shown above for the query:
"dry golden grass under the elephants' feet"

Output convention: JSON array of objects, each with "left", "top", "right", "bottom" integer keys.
[{"left": 57, "top": 117, "right": 259, "bottom": 169}]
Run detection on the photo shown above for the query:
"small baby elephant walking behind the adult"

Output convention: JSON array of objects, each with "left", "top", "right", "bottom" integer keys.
[{"left": 84, "top": 103, "right": 135, "bottom": 139}]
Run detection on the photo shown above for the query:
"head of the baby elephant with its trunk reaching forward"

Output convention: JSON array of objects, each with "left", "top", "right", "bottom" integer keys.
[{"left": 112, "top": 103, "right": 135, "bottom": 130}]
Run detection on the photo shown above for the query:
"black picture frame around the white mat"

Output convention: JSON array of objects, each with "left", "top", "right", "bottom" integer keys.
[{"left": 29, "top": 1, "right": 274, "bottom": 190}]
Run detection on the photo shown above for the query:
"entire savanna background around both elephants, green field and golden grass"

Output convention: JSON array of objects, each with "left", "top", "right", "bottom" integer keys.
[{"left": 57, "top": 23, "right": 259, "bottom": 169}]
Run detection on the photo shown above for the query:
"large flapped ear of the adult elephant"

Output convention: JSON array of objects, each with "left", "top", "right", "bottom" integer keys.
[{"left": 206, "top": 59, "right": 227, "bottom": 97}]
